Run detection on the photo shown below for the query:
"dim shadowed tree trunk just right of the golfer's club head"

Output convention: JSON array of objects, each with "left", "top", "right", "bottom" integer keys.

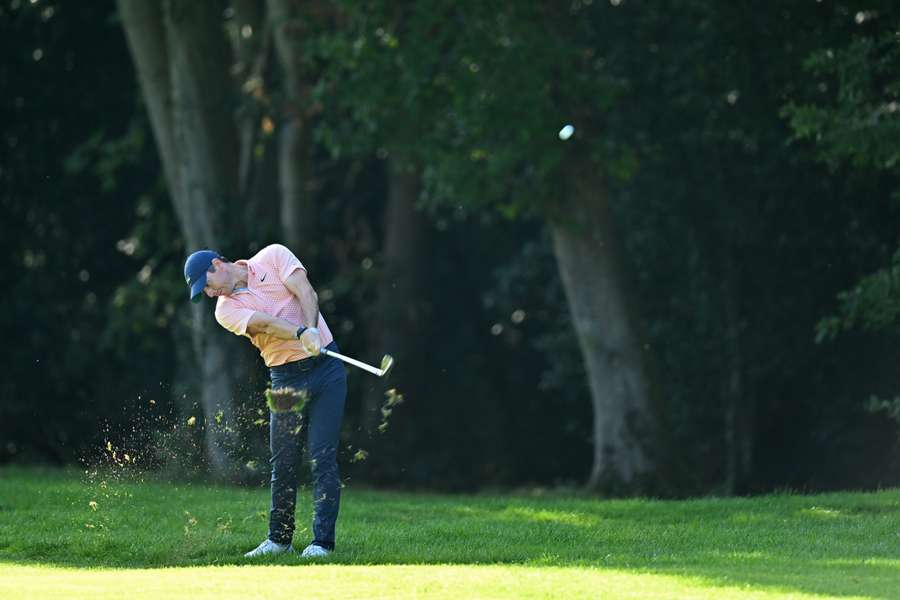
[{"left": 363, "top": 154, "right": 428, "bottom": 432}]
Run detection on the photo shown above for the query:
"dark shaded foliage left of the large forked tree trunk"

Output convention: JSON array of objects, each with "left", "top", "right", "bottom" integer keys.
[{"left": 0, "top": 2, "right": 167, "bottom": 463}]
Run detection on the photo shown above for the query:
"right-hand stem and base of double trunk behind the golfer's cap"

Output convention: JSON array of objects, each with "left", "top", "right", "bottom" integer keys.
[{"left": 166, "top": 0, "right": 241, "bottom": 479}]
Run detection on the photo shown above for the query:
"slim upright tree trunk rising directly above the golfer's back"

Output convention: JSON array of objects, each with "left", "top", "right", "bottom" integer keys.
[{"left": 268, "top": 0, "right": 317, "bottom": 255}]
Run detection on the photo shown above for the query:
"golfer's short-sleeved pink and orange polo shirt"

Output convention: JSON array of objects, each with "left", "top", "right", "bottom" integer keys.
[{"left": 216, "top": 244, "right": 334, "bottom": 367}]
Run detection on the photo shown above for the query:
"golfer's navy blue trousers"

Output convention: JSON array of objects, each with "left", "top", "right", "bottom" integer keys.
[{"left": 269, "top": 342, "right": 347, "bottom": 550}]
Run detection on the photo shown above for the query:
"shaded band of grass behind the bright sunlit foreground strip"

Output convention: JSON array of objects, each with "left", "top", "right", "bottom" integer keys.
[{"left": 0, "top": 470, "right": 900, "bottom": 598}]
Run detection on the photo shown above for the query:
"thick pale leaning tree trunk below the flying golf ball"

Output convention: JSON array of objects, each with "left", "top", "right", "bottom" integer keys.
[{"left": 550, "top": 165, "right": 654, "bottom": 489}]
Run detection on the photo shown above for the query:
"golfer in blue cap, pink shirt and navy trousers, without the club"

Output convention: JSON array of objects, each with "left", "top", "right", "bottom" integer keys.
[{"left": 184, "top": 244, "right": 347, "bottom": 557}]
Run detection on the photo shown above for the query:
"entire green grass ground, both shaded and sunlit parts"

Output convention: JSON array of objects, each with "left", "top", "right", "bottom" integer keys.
[{"left": 0, "top": 469, "right": 900, "bottom": 600}]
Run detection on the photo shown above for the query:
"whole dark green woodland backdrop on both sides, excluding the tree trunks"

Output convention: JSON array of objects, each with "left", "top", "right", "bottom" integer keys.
[{"left": 0, "top": 0, "right": 900, "bottom": 494}]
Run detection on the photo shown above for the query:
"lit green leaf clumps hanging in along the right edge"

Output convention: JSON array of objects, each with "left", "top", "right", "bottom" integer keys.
[{"left": 783, "top": 2, "right": 900, "bottom": 438}]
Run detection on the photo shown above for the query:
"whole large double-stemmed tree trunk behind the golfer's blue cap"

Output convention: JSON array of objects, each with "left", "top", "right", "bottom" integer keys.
[{"left": 119, "top": 0, "right": 246, "bottom": 478}]
